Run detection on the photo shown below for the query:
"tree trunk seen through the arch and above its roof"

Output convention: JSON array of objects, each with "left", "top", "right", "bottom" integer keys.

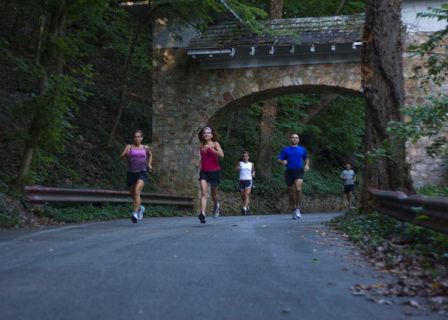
[{"left": 257, "top": 0, "right": 283, "bottom": 179}]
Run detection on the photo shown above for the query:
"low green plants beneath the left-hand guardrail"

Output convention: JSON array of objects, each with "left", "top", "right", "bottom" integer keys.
[{"left": 40, "top": 204, "right": 189, "bottom": 223}]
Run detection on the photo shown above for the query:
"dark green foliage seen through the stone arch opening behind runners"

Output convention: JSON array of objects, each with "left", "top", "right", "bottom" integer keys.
[{"left": 215, "top": 94, "right": 365, "bottom": 196}]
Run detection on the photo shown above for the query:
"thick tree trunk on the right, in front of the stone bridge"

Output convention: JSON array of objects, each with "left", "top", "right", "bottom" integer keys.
[{"left": 361, "top": 0, "right": 413, "bottom": 212}]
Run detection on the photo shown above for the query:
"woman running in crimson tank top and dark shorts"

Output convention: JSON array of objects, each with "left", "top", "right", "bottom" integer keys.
[{"left": 198, "top": 127, "right": 224, "bottom": 223}]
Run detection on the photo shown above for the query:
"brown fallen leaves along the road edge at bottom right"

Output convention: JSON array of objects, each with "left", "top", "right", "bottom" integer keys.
[{"left": 342, "top": 235, "right": 448, "bottom": 314}]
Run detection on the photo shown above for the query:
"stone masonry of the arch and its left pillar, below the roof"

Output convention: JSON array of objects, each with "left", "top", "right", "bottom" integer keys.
[{"left": 153, "top": 49, "right": 361, "bottom": 193}]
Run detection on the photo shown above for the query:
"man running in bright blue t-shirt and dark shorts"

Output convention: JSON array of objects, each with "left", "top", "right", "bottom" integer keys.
[{"left": 278, "top": 133, "right": 309, "bottom": 220}]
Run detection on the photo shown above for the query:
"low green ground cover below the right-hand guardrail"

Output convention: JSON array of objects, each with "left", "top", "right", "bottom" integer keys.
[{"left": 330, "top": 211, "right": 448, "bottom": 258}]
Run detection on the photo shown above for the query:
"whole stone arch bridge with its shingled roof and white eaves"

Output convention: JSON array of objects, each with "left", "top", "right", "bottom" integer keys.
[{"left": 152, "top": 15, "right": 443, "bottom": 193}]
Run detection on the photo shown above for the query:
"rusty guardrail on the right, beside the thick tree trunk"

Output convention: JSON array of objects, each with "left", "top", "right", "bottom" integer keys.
[{"left": 368, "top": 187, "right": 448, "bottom": 233}]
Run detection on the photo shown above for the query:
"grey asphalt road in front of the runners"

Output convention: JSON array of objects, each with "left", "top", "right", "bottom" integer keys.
[{"left": 0, "top": 214, "right": 446, "bottom": 320}]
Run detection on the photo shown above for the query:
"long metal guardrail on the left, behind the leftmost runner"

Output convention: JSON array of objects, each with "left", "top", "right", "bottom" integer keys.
[{"left": 24, "top": 186, "right": 193, "bottom": 208}]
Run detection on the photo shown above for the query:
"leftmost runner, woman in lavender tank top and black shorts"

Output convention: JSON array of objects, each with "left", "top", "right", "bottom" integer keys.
[{"left": 120, "top": 130, "right": 152, "bottom": 223}]
